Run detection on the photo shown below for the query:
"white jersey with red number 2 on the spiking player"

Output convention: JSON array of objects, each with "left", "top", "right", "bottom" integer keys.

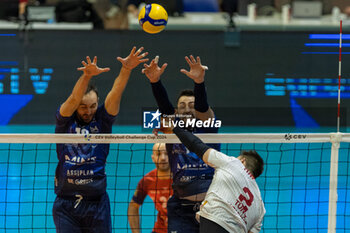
[{"left": 198, "top": 149, "right": 266, "bottom": 233}]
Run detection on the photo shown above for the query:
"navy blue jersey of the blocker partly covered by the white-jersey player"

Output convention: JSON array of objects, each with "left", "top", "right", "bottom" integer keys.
[{"left": 166, "top": 124, "right": 220, "bottom": 198}]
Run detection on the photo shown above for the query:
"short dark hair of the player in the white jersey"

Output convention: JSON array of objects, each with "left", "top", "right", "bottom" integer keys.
[{"left": 240, "top": 150, "right": 264, "bottom": 178}]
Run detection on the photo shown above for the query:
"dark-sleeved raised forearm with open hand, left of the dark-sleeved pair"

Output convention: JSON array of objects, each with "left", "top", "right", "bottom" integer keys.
[{"left": 142, "top": 56, "right": 175, "bottom": 115}]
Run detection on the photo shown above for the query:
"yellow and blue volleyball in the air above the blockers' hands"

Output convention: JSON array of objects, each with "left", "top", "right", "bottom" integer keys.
[{"left": 139, "top": 3, "right": 168, "bottom": 34}]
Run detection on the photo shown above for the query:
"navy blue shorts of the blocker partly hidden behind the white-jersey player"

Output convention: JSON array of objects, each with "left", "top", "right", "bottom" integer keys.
[{"left": 167, "top": 195, "right": 201, "bottom": 233}]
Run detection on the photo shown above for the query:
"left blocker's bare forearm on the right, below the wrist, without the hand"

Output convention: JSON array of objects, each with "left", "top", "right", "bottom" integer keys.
[{"left": 105, "top": 67, "right": 131, "bottom": 116}]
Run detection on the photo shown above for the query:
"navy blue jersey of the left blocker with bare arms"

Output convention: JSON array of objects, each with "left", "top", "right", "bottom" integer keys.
[{"left": 55, "top": 105, "right": 115, "bottom": 196}]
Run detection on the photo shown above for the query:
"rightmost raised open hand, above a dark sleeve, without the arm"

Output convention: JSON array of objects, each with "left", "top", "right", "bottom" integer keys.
[{"left": 180, "top": 55, "right": 208, "bottom": 83}]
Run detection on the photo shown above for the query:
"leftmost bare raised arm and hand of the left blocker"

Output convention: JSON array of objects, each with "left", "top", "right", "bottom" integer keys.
[{"left": 60, "top": 56, "right": 109, "bottom": 117}]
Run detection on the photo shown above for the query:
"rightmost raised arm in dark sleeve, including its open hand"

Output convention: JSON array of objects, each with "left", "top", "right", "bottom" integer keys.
[{"left": 180, "top": 55, "right": 214, "bottom": 121}]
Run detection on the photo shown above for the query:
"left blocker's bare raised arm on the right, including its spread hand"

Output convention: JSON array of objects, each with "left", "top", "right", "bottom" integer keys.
[{"left": 105, "top": 47, "right": 148, "bottom": 116}]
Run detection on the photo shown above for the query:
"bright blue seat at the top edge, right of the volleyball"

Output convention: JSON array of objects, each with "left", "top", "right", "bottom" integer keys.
[{"left": 183, "top": 0, "right": 219, "bottom": 12}]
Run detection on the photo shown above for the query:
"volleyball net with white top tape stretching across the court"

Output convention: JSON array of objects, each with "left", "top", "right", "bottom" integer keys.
[{"left": 0, "top": 133, "right": 350, "bottom": 233}]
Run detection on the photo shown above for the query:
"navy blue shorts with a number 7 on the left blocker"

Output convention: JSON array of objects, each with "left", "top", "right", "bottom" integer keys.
[{"left": 52, "top": 193, "right": 112, "bottom": 233}]
